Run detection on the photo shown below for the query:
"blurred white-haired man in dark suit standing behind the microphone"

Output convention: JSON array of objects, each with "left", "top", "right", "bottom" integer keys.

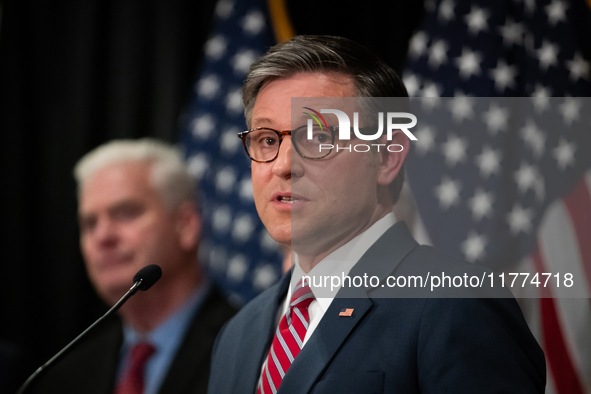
[{"left": 30, "top": 139, "right": 235, "bottom": 394}]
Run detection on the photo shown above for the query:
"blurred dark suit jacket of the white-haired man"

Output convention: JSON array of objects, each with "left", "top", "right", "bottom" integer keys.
[{"left": 27, "top": 287, "right": 236, "bottom": 394}]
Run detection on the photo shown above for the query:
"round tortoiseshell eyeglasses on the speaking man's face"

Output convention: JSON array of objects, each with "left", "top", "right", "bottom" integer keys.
[{"left": 238, "top": 125, "right": 338, "bottom": 163}]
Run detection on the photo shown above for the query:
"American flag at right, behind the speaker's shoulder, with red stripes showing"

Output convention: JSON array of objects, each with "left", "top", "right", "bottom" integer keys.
[{"left": 404, "top": 0, "right": 591, "bottom": 394}]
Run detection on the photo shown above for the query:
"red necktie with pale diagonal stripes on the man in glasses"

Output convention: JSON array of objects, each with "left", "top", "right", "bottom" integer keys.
[{"left": 257, "top": 281, "right": 314, "bottom": 394}]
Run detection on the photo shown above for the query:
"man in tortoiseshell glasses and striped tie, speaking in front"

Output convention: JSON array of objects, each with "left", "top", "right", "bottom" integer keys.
[{"left": 208, "top": 36, "right": 545, "bottom": 394}]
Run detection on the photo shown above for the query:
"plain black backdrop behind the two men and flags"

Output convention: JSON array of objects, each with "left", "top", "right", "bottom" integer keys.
[{"left": 0, "top": 0, "right": 422, "bottom": 392}]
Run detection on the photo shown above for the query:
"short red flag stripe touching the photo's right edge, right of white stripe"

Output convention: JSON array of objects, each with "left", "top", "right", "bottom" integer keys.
[{"left": 564, "top": 177, "right": 591, "bottom": 289}]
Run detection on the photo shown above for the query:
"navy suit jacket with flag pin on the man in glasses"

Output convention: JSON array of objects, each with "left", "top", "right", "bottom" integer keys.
[{"left": 208, "top": 222, "right": 546, "bottom": 394}]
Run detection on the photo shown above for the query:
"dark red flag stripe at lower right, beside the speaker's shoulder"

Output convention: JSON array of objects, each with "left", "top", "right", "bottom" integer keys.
[{"left": 532, "top": 248, "right": 584, "bottom": 394}]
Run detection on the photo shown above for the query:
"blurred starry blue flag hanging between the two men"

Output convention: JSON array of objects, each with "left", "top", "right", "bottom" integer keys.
[{"left": 180, "top": 0, "right": 282, "bottom": 305}]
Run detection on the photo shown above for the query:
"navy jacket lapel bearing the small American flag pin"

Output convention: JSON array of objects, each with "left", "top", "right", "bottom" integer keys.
[{"left": 280, "top": 222, "right": 418, "bottom": 394}]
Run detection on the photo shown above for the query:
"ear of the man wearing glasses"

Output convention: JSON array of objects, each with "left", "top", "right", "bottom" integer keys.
[{"left": 378, "top": 130, "right": 410, "bottom": 186}]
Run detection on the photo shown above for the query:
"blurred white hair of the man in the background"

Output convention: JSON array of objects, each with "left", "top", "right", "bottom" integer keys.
[{"left": 74, "top": 138, "right": 196, "bottom": 210}]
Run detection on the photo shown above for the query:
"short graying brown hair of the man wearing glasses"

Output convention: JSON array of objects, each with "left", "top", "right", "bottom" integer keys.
[{"left": 242, "top": 35, "right": 408, "bottom": 203}]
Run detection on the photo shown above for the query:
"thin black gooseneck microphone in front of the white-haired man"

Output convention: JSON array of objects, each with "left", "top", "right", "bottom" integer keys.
[{"left": 16, "top": 264, "right": 162, "bottom": 394}]
